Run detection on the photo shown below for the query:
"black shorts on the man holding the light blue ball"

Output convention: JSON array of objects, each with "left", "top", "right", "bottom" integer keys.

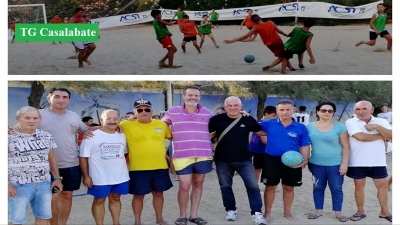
[{"left": 261, "top": 154, "right": 303, "bottom": 187}]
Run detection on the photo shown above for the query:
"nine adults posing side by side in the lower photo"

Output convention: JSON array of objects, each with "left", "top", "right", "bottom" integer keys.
[{"left": 8, "top": 87, "right": 392, "bottom": 225}]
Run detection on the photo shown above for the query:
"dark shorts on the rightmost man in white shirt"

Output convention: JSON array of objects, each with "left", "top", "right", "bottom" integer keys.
[{"left": 346, "top": 166, "right": 388, "bottom": 179}]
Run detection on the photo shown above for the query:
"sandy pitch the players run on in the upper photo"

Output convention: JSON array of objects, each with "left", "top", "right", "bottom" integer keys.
[{"left": 8, "top": 25, "right": 392, "bottom": 75}]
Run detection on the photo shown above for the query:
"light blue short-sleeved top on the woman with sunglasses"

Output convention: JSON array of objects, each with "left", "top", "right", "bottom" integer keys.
[{"left": 307, "top": 122, "right": 347, "bottom": 166}]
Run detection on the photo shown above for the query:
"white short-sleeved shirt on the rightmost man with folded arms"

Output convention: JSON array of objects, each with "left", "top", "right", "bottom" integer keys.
[{"left": 346, "top": 116, "right": 392, "bottom": 167}]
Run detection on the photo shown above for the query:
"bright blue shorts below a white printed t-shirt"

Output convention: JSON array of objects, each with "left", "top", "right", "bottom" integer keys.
[{"left": 87, "top": 181, "right": 129, "bottom": 198}]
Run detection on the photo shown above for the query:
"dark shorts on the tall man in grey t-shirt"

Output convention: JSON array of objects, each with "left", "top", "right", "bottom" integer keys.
[{"left": 51, "top": 166, "right": 82, "bottom": 194}]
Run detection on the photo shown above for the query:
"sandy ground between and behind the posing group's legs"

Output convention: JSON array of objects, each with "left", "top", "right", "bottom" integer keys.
[{"left": 22, "top": 153, "right": 392, "bottom": 225}]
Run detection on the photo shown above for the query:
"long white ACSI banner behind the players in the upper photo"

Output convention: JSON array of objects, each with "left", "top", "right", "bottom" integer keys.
[{"left": 92, "top": 0, "right": 383, "bottom": 29}]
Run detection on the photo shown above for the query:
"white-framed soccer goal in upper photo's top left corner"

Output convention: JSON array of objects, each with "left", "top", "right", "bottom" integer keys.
[{"left": 8, "top": 4, "right": 47, "bottom": 27}]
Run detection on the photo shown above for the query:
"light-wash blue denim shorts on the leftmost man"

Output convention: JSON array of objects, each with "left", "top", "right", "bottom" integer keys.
[{"left": 8, "top": 181, "right": 52, "bottom": 224}]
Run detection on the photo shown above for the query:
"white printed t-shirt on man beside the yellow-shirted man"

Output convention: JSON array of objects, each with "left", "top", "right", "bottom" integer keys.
[{"left": 79, "top": 130, "right": 129, "bottom": 185}]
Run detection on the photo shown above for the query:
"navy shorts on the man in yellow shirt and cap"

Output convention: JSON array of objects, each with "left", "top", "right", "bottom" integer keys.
[{"left": 129, "top": 169, "right": 173, "bottom": 195}]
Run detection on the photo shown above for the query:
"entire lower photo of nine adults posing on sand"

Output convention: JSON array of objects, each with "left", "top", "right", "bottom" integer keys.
[{"left": 8, "top": 80, "right": 393, "bottom": 225}]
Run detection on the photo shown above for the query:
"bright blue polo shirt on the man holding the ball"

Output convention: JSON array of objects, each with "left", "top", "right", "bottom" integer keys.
[{"left": 260, "top": 118, "right": 311, "bottom": 157}]
